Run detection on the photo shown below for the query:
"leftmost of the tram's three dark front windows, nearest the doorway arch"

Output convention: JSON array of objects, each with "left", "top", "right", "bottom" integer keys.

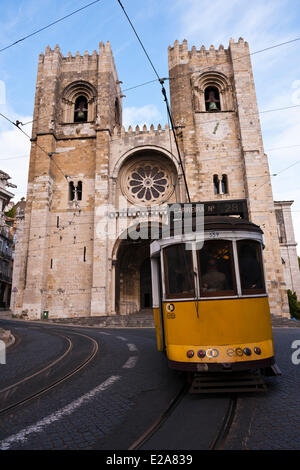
[{"left": 164, "top": 244, "right": 195, "bottom": 298}]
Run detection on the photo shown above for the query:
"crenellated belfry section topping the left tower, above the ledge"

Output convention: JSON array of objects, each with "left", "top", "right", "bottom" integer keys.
[{"left": 32, "top": 41, "right": 123, "bottom": 138}]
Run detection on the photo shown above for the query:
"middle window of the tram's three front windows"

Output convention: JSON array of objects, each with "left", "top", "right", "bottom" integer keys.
[{"left": 198, "top": 240, "right": 236, "bottom": 297}]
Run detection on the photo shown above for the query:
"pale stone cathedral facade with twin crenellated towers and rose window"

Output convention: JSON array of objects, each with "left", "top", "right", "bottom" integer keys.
[{"left": 11, "top": 39, "right": 298, "bottom": 318}]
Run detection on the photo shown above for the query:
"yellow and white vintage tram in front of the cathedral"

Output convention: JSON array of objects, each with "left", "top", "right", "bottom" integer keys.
[{"left": 150, "top": 216, "right": 277, "bottom": 375}]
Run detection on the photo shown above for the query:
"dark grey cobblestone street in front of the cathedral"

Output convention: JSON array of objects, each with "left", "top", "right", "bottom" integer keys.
[{"left": 0, "top": 320, "right": 300, "bottom": 450}]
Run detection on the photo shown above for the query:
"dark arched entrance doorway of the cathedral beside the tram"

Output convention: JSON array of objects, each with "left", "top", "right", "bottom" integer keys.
[{"left": 116, "top": 239, "right": 152, "bottom": 315}]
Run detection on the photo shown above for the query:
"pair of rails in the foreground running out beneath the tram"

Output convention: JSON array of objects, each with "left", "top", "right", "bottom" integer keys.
[{"left": 128, "top": 383, "right": 237, "bottom": 450}]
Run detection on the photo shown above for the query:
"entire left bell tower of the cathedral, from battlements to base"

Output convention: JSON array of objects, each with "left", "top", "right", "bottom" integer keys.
[{"left": 16, "top": 42, "right": 122, "bottom": 318}]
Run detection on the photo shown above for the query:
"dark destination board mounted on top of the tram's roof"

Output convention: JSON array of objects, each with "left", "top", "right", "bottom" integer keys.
[{"left": 168, "top": 199, "right": 249, "bottom": 226}]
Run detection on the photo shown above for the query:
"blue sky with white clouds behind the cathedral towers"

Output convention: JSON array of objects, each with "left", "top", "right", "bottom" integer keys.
[{"left": 0, "top": 0, "right": 300, "bottom": 254}]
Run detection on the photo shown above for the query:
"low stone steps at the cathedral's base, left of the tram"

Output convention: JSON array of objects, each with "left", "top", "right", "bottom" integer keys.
[{"left": 44, "top": 309, "right": 154, "bottom": 328}]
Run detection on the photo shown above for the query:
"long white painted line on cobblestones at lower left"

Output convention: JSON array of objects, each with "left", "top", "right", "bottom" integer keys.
[{"left": 0, "top": 375, "right": 121, "bottom": 450}]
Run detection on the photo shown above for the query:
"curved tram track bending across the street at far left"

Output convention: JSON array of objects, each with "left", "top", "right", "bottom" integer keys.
[{"left": 0, "top": 329, "right": 99, "bottom": 416}]
